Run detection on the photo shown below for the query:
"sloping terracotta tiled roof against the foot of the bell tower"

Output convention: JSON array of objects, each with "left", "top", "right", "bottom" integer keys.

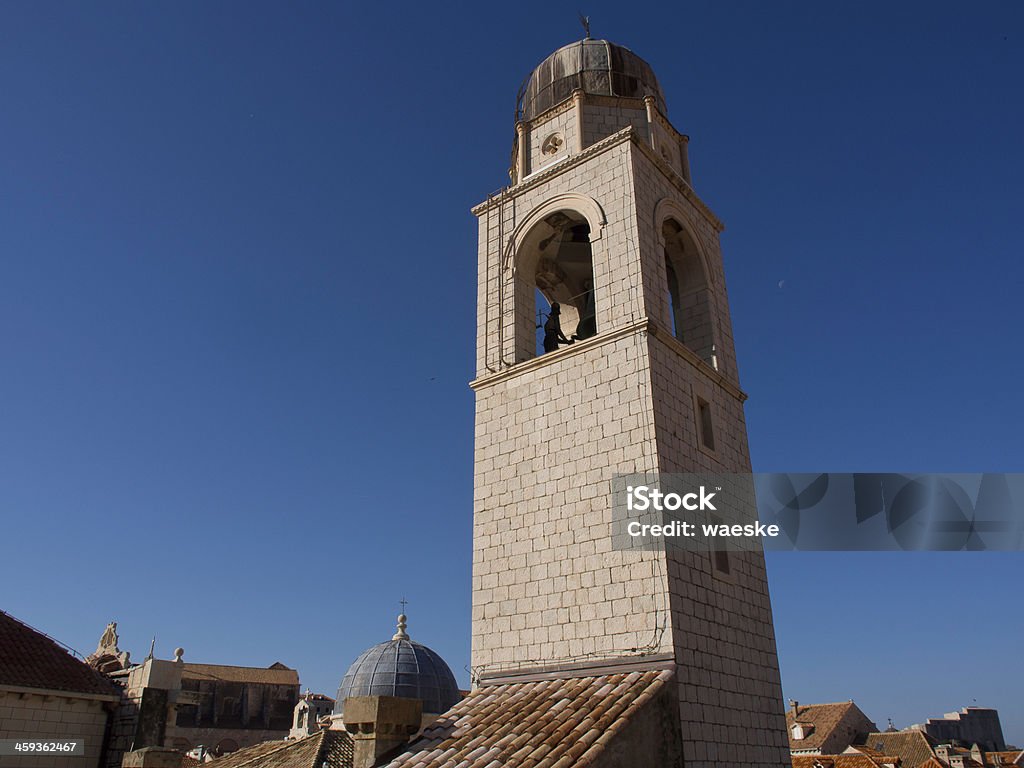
[{"left": 380, "top": 670, "right": 672, "bottom": 768}]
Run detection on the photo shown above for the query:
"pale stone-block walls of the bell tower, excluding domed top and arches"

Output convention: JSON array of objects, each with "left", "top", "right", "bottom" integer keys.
[{"left": 472, "top": 115, "right": 787, "bottom": 768}]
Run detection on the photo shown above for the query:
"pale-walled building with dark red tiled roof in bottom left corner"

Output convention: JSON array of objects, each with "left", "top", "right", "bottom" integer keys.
[{"left": 0, "top": 611, "right": 121, "bottom": 768}]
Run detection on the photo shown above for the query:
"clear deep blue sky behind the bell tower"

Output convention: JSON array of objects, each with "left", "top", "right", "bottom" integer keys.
[{"left": 0, "top": 0, "right": 1024, "bottom": 742}]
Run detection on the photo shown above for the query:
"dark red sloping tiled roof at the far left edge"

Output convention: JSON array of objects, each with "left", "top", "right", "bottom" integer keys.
[{"left": 0, "top": 610, "right": 121, "bottom": 696}]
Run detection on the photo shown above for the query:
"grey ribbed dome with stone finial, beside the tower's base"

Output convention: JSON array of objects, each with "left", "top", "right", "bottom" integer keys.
[{"left": 335, "top": 615, "right": 462, "bottom": 715}]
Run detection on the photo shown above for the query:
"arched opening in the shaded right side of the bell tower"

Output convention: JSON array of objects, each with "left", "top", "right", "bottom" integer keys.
[{"left": 662, "top": 218, "right": 718, "bottom": 368}]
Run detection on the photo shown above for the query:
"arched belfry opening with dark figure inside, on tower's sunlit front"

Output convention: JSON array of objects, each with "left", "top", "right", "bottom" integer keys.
[{"left": 516, "top": 210, "right": 597, "bottom": 361}]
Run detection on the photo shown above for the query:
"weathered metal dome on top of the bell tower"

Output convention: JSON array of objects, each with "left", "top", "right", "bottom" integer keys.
[{"left": 519, "top": 38, "right": 668, "bottom": 120}]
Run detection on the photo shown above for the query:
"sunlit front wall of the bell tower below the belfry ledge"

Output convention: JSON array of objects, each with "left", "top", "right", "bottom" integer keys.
[{"left": 472, "top": 335, "right": 671, "bottom": 672}]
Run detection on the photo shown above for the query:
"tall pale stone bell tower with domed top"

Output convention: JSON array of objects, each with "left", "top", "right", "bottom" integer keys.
[{"left": 472, "top": 38, "right": 788, "bottom": 768}]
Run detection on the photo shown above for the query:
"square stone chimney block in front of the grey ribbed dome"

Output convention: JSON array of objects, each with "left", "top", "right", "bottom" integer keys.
[{"left": 344, "top": 696, "right": 423, "bottom": 768}]
